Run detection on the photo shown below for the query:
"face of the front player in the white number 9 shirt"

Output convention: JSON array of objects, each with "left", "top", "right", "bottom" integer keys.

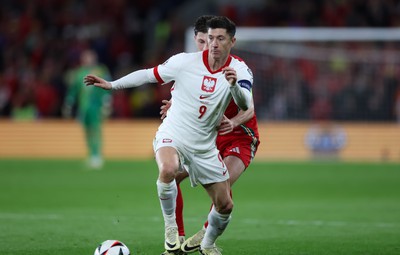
[{"left": 208, "top": 28, "right": 236, "bottom": 60}]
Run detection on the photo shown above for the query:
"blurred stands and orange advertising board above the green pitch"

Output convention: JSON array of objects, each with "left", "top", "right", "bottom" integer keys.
[{"left": 0, "top": 0, "right": 400, "bottom": 161}]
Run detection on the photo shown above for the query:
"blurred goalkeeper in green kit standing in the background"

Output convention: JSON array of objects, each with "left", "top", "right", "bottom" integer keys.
[{"left": 63, "top": 50, "right": 111, "bottom": 169}]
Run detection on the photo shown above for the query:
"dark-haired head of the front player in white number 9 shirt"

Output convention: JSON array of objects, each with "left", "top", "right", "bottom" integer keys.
[{"left": 207, "top": 16, "right": 236, "bottom": 59}]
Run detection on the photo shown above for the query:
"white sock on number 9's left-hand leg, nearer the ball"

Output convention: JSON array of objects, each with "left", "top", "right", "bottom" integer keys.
[{"left": 157, "top": 180, "right": 178, "bottom": 226}]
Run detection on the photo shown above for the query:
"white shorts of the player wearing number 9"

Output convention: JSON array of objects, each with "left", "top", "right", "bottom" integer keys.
[{"left": 153, "top": 132, "right": 229, "bottom": 187}]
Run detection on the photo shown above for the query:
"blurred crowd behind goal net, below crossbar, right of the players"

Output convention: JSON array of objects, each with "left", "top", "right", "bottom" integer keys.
[{"left": 236, "top": 42, "right": 400, "bottom": 121}]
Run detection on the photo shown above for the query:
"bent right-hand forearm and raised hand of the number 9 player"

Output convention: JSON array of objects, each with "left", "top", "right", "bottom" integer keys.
[{"left": 222, "top": 66, "right": 251, "bottom": 111}]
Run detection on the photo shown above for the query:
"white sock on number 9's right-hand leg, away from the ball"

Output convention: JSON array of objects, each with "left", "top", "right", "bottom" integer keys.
[{"left": 200, "top": 207, "right": 231, "bottom": 248}]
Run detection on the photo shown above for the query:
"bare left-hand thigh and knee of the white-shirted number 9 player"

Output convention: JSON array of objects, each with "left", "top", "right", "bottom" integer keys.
[{"left": 156, "top": 147, "right": 179, "bottom": 182}]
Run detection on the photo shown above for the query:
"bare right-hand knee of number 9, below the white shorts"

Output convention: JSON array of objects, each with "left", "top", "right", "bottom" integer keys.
[{"left": 203, "top": 180, "right": 233, "bottom": 214}]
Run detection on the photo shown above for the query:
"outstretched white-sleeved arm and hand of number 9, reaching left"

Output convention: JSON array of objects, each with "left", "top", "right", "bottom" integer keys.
[{"left": 83, "top": 69, "right": 157, "bottom": 90}]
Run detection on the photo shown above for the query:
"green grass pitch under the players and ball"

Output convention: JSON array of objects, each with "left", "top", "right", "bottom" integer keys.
[{"left": 0, "top": 160, "right": 400, "bottom": 255}]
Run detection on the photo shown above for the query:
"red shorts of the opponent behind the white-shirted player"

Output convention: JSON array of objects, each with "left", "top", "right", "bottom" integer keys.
[{"left": 217, "top": 135, "right": 260, "bottom": 168}]
